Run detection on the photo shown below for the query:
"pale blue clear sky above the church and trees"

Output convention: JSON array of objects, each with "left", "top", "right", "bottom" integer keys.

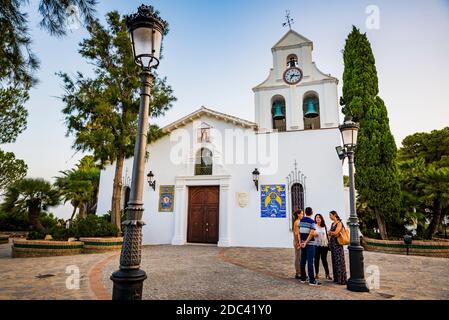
[{"left": 1, "top": 0, "right": 449, "bottom": 216}]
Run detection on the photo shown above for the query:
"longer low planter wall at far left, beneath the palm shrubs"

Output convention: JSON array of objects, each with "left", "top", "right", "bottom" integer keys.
[{"left": 12, "top": 239, "right": 83, "bottom": 258}]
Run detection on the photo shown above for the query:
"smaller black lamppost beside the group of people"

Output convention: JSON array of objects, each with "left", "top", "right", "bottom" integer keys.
[{"left": 336, "top": 120, "right": 369, "bottom": 292}]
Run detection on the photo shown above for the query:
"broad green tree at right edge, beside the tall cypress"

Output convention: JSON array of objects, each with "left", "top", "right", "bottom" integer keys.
[{"left": 399, "top": 127, "right": 449, "bottom": 238}]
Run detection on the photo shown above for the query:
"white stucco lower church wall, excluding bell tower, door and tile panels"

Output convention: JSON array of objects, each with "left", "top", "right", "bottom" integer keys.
[{"left": 98, "top": 117, "right": 345, "bottom": 247}]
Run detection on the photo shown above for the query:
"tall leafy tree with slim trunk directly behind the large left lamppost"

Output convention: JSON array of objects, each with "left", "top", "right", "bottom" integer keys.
[{"left": 59, "top": 11, "right": 176, "bottom": 228}]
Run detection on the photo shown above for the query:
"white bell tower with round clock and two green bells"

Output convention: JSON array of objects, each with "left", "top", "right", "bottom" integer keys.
[{"left": 253, "top": 29, "right": 339, "bottom": 132}]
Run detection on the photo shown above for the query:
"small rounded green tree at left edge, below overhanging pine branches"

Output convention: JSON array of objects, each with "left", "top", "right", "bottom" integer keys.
[{"left": 0, "top": 150, "right": 28, "bottom": 192}]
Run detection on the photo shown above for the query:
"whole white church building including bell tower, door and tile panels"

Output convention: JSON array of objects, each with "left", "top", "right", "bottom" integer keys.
[{"left": 97, "top": 30, "right": 346, "bottom": 248}]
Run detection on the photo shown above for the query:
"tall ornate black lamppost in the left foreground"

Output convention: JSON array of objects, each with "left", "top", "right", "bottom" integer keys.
[{"left": 111, "top": 5, "right": 167, "bottom": 300}]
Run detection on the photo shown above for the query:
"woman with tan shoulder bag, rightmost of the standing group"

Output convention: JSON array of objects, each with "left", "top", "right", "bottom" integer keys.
[{"left": 329, "top": 211, "right": 347, "bottom": 285}]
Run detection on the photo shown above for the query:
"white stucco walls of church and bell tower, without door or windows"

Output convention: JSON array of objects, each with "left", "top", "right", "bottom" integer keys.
[{"left": 97, "top": 31, "right": 347, "bottom": 248}]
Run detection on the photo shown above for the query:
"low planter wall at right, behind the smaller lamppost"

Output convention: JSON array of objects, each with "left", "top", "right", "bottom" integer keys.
[{"left": 362, "top": 237, "right": 449, "bottom": 258}]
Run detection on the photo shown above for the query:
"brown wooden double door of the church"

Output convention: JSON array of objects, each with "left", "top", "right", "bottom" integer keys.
[{"left": 187, "top": 186, "right": 220, "bottom": 243}]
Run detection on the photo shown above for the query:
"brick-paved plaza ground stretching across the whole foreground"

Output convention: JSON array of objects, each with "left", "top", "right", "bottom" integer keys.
[{"left": 0, "top": 244, "right": 449, "bottom": 300}]
